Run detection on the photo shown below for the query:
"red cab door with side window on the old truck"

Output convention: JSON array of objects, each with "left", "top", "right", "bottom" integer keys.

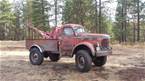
[{"left": 60, "top": 27, "right": 76, "bottom": 56}]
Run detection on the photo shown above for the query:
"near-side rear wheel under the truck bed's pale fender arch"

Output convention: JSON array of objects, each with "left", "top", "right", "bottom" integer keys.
[{"left": 29, "top": 48, "right": 44, "bottom": 65}]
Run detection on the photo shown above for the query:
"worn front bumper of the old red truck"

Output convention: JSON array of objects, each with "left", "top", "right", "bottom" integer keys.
[{"left": 96, "top": 47, "right": 112, "bottom": 57}]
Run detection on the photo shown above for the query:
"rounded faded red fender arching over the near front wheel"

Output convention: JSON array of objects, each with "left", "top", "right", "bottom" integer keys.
[{"left": 72, "top": 42, "right": 95, "bottom": 57}]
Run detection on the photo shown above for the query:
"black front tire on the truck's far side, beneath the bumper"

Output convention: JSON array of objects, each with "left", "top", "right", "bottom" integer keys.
[{"left": 93, "top": 56, "right": 107, "bottom": 67}]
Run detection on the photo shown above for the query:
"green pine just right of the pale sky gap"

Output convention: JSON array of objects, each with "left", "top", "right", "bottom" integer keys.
[{"left": 113, "top": 0, "right": 127, "bottom": 42}]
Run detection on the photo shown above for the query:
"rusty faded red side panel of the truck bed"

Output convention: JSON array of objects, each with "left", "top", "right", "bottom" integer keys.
[{"left": 26, "top": 39, "right": 58, "bottom": 52}]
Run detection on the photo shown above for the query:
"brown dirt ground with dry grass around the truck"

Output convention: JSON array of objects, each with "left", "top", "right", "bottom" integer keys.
[{"left": 0, "top": 41, "right": 145, "bottom": 81}]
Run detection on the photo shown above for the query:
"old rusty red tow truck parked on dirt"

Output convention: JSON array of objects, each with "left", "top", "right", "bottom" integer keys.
[{"left": 26, "top": 24, "right": 112, "bottom": 72}]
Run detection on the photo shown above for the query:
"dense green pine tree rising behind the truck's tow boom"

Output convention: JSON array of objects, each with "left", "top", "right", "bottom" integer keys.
[{"left": 31, "top": 0, "right": 50, "bottom": 31}]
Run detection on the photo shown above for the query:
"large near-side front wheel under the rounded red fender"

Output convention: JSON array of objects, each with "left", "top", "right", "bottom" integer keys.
[{"left": 75, "top": 50, "right": 92, "bottom": 72}]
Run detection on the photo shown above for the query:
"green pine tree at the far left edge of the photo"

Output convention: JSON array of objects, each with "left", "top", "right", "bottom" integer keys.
[{"left": 0, "top": 0, "right": 15, "bottom": 40}]
